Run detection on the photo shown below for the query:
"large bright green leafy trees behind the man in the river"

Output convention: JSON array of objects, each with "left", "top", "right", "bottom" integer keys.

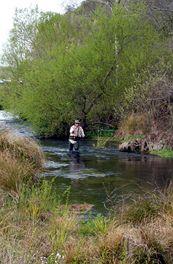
[{"left": 1, "top": 4, "right": 164, "bottom": 135}]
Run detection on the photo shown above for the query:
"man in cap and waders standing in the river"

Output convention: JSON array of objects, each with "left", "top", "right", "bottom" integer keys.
[{"left": 69, "top": 120, "right": 85, "bottom": 153}]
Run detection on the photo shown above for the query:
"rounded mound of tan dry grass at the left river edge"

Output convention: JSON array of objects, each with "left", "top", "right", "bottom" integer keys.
[{"left": 0, "top": 131, "right": 43, "bottom": 192}]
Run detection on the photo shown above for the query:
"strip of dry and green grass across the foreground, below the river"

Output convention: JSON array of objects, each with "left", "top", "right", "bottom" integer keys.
[{"left": 0, "top": 182, "right": 173, "bottom": 264}]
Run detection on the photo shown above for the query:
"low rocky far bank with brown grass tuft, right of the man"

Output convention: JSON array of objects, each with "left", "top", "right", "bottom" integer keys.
[{"left": 115, "top": 110, "right": 173, "bottom": 158}]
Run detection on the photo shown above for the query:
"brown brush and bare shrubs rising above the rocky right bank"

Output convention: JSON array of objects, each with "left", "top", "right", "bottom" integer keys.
[{"left": 117, "top": 71, "right": 173, "bottom": 151}]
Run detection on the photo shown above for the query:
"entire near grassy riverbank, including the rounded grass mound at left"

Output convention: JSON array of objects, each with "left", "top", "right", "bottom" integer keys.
[{"left": 0, "top": 131, "right": 173, "bottom": 264}]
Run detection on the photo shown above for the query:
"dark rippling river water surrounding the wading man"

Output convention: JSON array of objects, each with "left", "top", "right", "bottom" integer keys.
[{"left": 0, "top": 111, "right": 173, "bottom": 213}]
